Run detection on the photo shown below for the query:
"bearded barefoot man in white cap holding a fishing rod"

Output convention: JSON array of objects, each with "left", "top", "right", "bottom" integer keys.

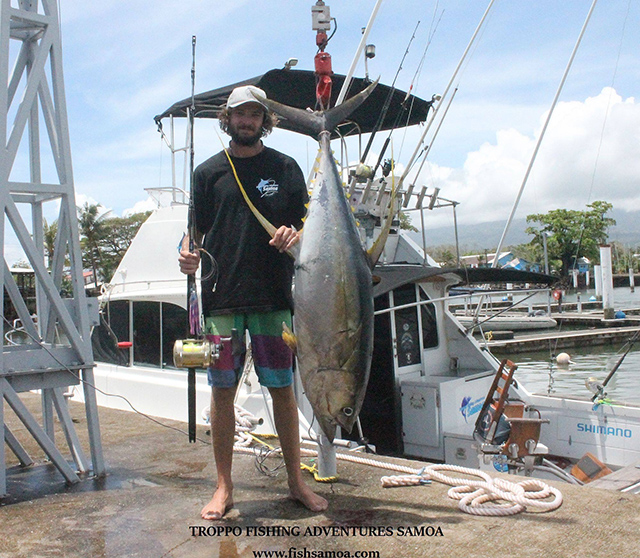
[{"left": 178, "top": 85, "right": 328, "bottom": 520}]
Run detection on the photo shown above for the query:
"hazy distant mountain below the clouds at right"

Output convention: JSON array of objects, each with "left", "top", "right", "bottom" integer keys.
[{"left": 411, "top": 209, "right": 640, "bottom": 253}]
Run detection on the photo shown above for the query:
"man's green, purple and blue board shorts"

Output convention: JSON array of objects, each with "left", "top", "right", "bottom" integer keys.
[{"left": 205, "top": 310, "right": 293, "bottom": 388}]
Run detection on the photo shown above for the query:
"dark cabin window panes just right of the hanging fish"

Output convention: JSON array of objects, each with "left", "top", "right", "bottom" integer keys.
[{"left": 393, "top": 283, "right": 438, "bottom": 366}]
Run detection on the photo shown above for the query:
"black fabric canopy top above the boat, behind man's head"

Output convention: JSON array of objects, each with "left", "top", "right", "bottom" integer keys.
[{"left": 155, "top": 69, "right": 432, "bottom": 135}]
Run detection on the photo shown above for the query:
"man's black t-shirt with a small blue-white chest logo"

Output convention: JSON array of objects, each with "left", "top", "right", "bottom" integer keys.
[{"left": 194, "top": 147, "right": 308, "bottom": 315}]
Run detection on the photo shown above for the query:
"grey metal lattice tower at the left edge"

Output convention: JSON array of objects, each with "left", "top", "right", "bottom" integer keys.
[{"left": 0, "top": 0, "right": 105, "bottom": 496}]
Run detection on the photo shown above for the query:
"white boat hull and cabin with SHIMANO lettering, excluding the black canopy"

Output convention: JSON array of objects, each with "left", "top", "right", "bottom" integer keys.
[{"left": 85, "top": 186, "right": 640, "bottom": 488}]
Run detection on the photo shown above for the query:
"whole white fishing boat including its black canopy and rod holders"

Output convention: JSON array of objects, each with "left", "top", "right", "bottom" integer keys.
[{"left": 86, "top": 69, "right": 640, "bottom": 490}]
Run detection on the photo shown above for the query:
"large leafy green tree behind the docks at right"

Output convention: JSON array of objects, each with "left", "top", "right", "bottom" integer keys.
[{"left": 525, "top": 201, "right": 616, "bottom": 277}]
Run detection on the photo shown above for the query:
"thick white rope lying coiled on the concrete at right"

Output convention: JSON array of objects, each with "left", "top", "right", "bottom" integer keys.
[{"left": 380, "top": 464, "right": 562, "bottom": 516}]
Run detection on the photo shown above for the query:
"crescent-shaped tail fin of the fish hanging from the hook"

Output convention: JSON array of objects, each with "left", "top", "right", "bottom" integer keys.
[{"left": 260, "top": 80, "right": 379, "bottom": 139}]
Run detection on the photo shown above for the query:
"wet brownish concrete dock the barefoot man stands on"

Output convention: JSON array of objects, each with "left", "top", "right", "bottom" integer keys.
[{"left": 0, "top": 393, "right": 640, "bottom": 558}]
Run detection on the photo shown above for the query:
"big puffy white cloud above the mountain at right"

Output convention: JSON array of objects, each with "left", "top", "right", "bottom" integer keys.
[{"left": 422, "top": 88, "right": 640, "bottom": 229}]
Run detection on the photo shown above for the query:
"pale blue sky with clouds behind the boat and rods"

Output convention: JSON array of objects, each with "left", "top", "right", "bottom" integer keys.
[{"left": 5, "top": 0, "right": 640, "bottom": 264}]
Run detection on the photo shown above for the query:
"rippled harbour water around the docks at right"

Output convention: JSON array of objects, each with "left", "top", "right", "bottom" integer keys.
[{"left": 495, "top": 287, "right": 640, "bottom": 405}]
